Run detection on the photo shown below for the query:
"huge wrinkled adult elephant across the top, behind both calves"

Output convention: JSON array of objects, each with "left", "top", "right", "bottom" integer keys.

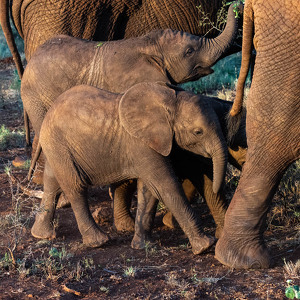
[{"left": 0, "top": 0, "right": 242, "bottom": 145}]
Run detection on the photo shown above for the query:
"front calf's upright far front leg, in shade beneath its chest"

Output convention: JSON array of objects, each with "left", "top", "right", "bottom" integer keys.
[{"left": 131, "top": 180, "right": 158, "bottom": 249}]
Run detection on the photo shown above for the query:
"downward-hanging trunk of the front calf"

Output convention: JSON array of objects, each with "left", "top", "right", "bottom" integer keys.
[{"left": 211, "top": 138, "right": 228, "bottom": 193}]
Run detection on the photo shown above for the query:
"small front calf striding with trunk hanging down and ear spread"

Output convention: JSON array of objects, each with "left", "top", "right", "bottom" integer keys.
[{"left": 31, "top": 83, "right": 227, "bottom": 253}]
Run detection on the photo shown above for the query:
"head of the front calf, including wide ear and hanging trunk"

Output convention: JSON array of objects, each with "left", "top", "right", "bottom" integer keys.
[{"left": 119, "top": 83, "right": 227, "bottom": 193}]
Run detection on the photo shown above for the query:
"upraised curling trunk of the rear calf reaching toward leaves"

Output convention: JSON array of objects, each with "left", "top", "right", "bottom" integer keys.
[{"left": 201, "top": 3, "right": 243, "bottom": 67}]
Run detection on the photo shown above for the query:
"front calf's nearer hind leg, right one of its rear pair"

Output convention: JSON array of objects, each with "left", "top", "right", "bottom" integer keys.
[{"left": 65, "top": 188, "right": 109, "bottom": 247}]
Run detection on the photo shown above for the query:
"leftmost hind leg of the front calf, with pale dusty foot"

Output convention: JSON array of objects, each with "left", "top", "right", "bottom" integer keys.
[{"left": 31, "top": 163, "right": 61, "bottom": 239}]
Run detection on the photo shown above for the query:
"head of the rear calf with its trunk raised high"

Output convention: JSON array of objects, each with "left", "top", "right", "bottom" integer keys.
[{"left": 139, "top": 5, "right": 243, "bottom": 84}]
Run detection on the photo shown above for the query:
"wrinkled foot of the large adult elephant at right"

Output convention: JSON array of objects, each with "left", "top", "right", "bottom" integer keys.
[{"left": 215, "top": 233, "right": 270, "bottom": 269}]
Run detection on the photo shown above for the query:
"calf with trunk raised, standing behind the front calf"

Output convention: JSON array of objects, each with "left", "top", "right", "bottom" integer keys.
[{"left": 21, "top": 23, "right": 236, "bottom": 182}]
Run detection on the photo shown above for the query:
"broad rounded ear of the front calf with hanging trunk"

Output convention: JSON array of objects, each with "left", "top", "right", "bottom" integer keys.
[{"left": 119, "top": 83, "right": 176, "bottom": 156}]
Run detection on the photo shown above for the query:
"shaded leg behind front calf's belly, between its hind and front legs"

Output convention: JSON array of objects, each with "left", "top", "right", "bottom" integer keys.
[{"left": 111, "top": 180, "right": 136, "bottom": 232}]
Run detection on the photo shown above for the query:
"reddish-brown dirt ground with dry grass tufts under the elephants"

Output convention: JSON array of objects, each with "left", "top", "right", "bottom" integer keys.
[{"left": 0, "top": 59, "right": 300, "bottom": 299}]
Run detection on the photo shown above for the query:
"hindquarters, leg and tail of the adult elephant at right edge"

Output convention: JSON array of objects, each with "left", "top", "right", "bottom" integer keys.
[{"left": 216, "top": 0, "right": 300, "bottom": 268}]
